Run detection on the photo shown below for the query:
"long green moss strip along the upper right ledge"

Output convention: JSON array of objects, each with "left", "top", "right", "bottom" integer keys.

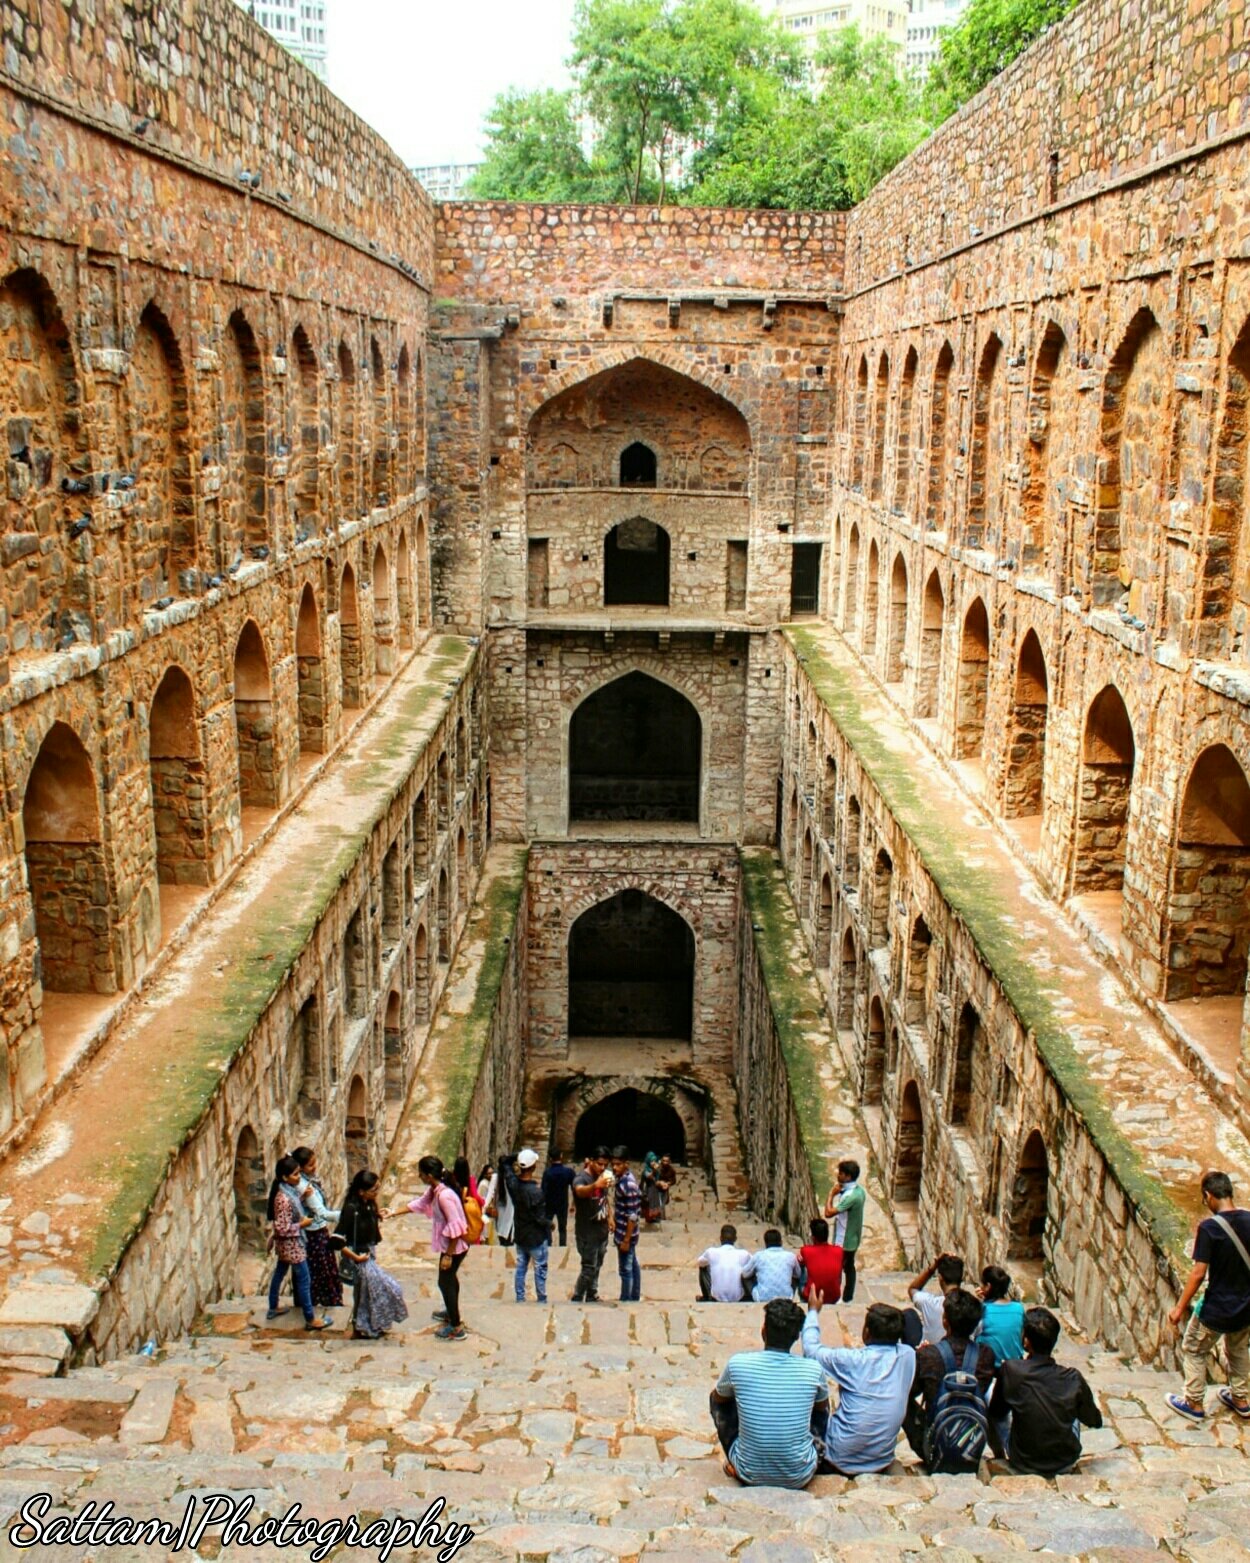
[{"left": 784, "top": 627, "right": 1189, "bottom": 1255}]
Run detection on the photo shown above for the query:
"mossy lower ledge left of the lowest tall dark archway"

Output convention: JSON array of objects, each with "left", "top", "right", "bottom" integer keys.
[{"left": 436, "top": 847, "right": 530, "bottom": 1164}]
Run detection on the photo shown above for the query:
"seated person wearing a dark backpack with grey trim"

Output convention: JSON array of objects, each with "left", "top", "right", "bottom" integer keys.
[{"left": 903, "top": 1286, "right": 994, "bottom": 1474}]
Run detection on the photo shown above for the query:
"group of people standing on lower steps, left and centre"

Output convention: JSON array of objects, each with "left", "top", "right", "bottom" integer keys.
[{"left": 259, "top": 1146, "right": 677, "bottom": 1341}]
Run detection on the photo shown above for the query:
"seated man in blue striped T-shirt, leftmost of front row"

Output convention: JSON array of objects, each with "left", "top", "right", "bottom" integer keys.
[{"left": 711, "top": 1297, "right": 830, "bottom": 1488}]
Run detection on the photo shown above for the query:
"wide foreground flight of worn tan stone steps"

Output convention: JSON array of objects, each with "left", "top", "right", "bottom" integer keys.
[{"left": 0, "top": 1174, "right": 1250, "bottom": 1563}]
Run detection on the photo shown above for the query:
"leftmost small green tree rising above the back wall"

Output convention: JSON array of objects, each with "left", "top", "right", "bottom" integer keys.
[{"left": 466, "top": 88, "right": 600, "bottom": 202}]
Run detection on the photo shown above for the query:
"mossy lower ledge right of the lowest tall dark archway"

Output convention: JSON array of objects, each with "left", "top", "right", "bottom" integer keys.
[{"left": 739, "top": 847, "right": 833, "bottom": 1197}]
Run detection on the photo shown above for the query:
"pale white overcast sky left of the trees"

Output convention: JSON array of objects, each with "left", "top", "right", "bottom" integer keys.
[{"left": 327, "top": 0, "right": 573, "bottom": 166}]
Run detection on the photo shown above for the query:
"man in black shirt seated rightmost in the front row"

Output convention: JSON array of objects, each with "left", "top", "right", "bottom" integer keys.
[{"left": 989, "top": 1308, "right": 1103, "bottom": 1475}]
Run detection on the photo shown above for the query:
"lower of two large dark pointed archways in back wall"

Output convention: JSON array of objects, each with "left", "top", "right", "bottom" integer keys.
[{"left": 569, "top": 889, "right": 694, "bottom": 1041}]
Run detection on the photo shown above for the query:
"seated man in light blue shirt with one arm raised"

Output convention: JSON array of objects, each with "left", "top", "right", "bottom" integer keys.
[{"left": 803, "top": 1291, "right": 916, "bottom": 1475}]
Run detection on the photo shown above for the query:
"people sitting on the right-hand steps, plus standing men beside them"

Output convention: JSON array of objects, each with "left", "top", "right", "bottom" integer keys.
[{"left": 698, "top": 1163, "right": 1250, "bottom": 1486}]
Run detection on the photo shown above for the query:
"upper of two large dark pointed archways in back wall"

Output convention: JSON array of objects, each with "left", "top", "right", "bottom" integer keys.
[{"left": 569, "top": 672, "right": 703, "bottom": 824}]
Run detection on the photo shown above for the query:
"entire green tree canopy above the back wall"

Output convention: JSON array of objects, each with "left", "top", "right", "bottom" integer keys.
[{"left": 469, "top": 0, "right": 1077, "bottom": 209}]
